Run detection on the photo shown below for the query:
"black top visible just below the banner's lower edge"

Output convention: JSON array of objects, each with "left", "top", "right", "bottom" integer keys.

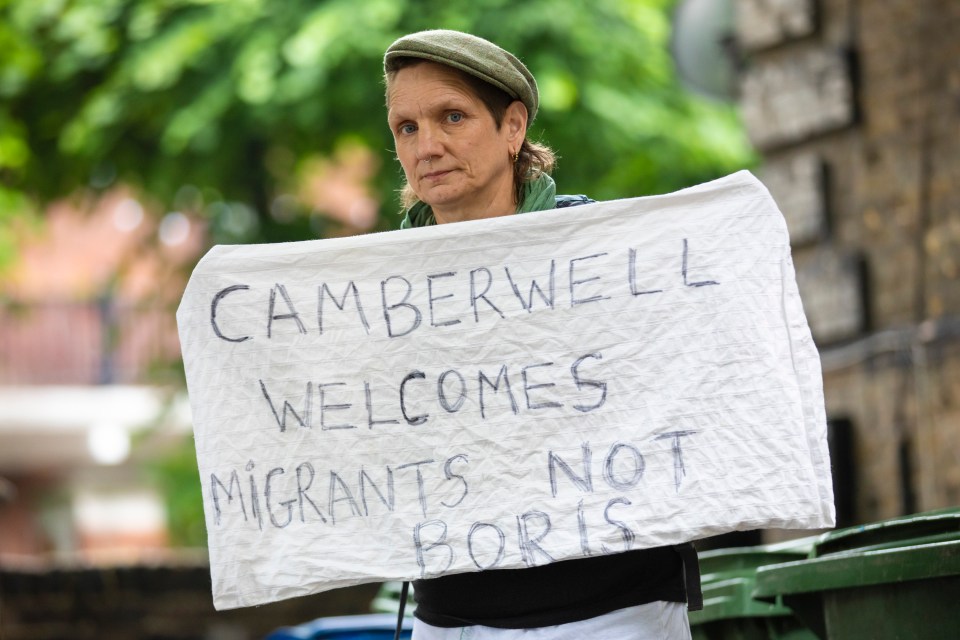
[{"left": 413, "top": 547, "right": 686, "bottom": 629}]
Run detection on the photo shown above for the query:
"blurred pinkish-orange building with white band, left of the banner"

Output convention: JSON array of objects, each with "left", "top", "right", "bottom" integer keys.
[{"left": 0, "top": 191, "right": 201, "bottom": 561}]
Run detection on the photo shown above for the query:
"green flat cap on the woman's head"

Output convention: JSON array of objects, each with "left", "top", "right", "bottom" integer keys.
[{"left": 383, "top": 29, "right": 540, "bottom": 126}]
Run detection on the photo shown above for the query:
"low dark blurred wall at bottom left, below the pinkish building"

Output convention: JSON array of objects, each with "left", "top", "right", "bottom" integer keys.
[{"left": 0, "top": 559, "right": 379, "bottom": 640}]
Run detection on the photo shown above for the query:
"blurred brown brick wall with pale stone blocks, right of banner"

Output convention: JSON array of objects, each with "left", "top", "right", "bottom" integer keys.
[{"left": 735, "top": 0, "right": 960, "bottom": 524}]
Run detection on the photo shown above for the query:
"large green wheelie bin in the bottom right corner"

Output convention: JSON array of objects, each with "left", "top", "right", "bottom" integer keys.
[{"left": 753, "top": 509, "right": 960, "bottom": 640}]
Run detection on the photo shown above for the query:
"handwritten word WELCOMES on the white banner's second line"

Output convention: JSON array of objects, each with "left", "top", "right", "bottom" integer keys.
[{"left": 258, "top": 353, "right": 607, "bottom": 433}]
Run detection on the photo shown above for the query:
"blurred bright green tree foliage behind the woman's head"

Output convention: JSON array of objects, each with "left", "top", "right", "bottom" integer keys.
[{"left": 0, "top": 0, "right": 750, "bottom": 242}]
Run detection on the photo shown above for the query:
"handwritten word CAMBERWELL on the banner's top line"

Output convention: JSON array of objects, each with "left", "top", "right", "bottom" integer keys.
[{"left": 210, "top": 238, "right": 719, "bottom": 342}]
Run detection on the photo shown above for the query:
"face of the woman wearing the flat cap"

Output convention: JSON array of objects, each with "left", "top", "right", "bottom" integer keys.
[{"left": 387, "top": 62, "right": 527, "bottom": 223}]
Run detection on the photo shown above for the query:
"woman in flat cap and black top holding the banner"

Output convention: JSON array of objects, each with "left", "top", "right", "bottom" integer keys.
[{"left": 384, "top": 30, "right": 699, "bottom": 640}]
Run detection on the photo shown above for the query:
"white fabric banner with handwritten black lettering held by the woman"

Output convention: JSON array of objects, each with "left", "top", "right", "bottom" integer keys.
[{"left": 177, "top": 171, "right": 834, "bottom": 609}]
